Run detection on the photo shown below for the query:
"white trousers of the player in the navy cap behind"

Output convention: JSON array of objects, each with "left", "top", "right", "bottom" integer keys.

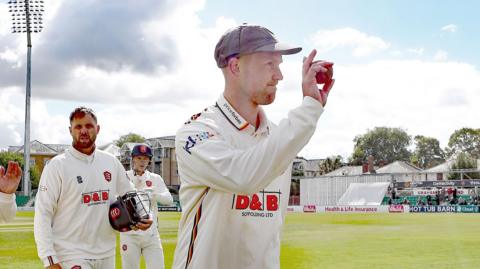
[{"left": 120, "top": 232, "right": 165, "bottom": 269}]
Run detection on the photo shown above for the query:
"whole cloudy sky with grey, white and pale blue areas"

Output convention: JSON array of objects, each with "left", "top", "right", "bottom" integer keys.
[{"left": 0, "top": 0, "right": 480, "bottom": 158}]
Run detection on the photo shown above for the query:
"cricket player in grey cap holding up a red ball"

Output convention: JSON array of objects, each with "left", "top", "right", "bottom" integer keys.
[{"left": 173, "top": 25, "right": 334, "bottom": 269}]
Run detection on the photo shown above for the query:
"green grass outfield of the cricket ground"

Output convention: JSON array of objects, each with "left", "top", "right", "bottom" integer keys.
[{"left": 0, "top": 212, "right": 480, "bottom": 269}]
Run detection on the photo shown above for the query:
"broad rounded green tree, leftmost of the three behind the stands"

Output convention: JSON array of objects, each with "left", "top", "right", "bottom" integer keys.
[{"left": 350, "top": 127, "right": 411, "bottom": 165}]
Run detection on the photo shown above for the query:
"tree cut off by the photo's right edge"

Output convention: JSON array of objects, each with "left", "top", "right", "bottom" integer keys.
[{"left": 447, "top": 128, "right": 480, "bottom": 159}]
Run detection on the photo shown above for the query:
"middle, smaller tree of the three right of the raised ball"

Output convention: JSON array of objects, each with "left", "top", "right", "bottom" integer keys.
[{"left": 410, "top": 135, "right": 445, "bottom": 169}]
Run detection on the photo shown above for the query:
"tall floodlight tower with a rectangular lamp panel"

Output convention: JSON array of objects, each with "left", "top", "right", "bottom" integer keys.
[{"left": 8, "top": 0, "right": 44, "bottom": 196}]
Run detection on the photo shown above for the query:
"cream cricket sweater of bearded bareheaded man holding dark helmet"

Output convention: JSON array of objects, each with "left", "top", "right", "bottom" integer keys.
[{"left": 34, "top": 146, "right": 133, "bottom": 266}]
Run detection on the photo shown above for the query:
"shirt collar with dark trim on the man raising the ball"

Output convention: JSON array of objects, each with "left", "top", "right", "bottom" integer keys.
[{"left": 216, "top": 94, "right": 270, "bottom": 136}]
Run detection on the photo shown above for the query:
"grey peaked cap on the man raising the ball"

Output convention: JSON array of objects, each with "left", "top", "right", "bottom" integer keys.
[{"left": 215, "top": 24, "right": 302, "bottom": 68}]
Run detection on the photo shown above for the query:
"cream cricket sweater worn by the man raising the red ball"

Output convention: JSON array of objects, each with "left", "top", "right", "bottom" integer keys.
[{"left": 173, "top": 95, "right": 323, "bottom": 269}]
